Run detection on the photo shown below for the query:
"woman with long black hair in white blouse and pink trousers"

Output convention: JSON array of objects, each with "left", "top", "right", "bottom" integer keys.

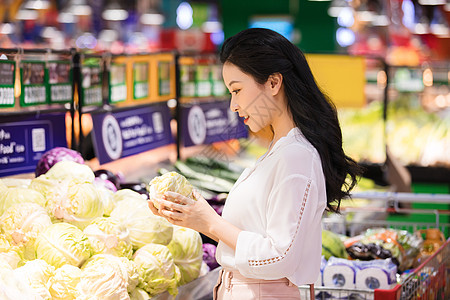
[{"left": 149, "top": 28, "right": 360, "bottom": 299}]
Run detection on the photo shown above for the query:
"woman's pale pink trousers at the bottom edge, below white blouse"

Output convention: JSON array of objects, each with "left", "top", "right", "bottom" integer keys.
[{"left": 213, "top": 269, "right": 300, "bottom": 300}]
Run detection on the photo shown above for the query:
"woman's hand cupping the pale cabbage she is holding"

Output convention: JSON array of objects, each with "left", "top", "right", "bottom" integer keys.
[{"left": 155, "top": 190, "right": 219, "bottom": 235}]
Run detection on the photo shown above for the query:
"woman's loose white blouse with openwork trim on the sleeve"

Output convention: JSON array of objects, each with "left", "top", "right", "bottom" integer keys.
[{"left": 216, "top": 128, "right": 326, "bottom": 285}]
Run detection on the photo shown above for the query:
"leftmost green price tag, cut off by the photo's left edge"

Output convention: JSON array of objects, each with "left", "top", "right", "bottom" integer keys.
[{"left": 0, "top": 60, "right": 16, "bottom": 108}]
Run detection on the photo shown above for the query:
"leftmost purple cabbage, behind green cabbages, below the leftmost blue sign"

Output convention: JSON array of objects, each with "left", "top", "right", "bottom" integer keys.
[{"left": 35, "top": 147, "right": 84, "bottom": 177}]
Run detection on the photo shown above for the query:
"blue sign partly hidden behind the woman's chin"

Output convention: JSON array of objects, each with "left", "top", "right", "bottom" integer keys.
[{"left": 180, "top": 101, "right": 248, "bottom": 147}]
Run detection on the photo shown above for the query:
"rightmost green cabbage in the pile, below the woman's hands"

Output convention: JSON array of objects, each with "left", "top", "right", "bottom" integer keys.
[{"left": 167, "top": 226, "right": 203, "bottom": 285}]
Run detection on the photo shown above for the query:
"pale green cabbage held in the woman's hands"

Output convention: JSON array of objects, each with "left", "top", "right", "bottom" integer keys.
[{"left": 147, "top": 172, "right": 193, "bottom": 208}]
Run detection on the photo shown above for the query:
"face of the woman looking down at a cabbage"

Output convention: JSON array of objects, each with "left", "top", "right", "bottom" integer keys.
[{"left": 222, "top": 62, "right": 276, "bottom": 132}]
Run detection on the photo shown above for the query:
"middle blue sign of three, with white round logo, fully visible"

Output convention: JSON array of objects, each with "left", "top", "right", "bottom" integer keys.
[{"left": 92, "top": 103, "right": 173, "bottom": 164}]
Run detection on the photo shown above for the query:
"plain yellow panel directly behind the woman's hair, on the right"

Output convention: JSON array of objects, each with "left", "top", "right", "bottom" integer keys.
[{"left": 305, "top": 54, "right": 366, "bottom": 108}]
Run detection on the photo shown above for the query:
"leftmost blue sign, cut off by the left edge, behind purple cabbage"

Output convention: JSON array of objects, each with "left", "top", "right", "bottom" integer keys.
[{"left": 0, "top": 112, "right": 67, "bottom": 177}]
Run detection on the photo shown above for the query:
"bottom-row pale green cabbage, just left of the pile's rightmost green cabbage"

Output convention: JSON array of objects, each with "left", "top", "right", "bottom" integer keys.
[{"left": 133, "top": 244, "right": 179, "bottom": 297}]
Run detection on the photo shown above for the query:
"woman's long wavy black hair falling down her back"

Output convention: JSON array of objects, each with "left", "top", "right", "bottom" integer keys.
[{"left": 220, "top": 28, "right": 362, "bottom": 212}]
